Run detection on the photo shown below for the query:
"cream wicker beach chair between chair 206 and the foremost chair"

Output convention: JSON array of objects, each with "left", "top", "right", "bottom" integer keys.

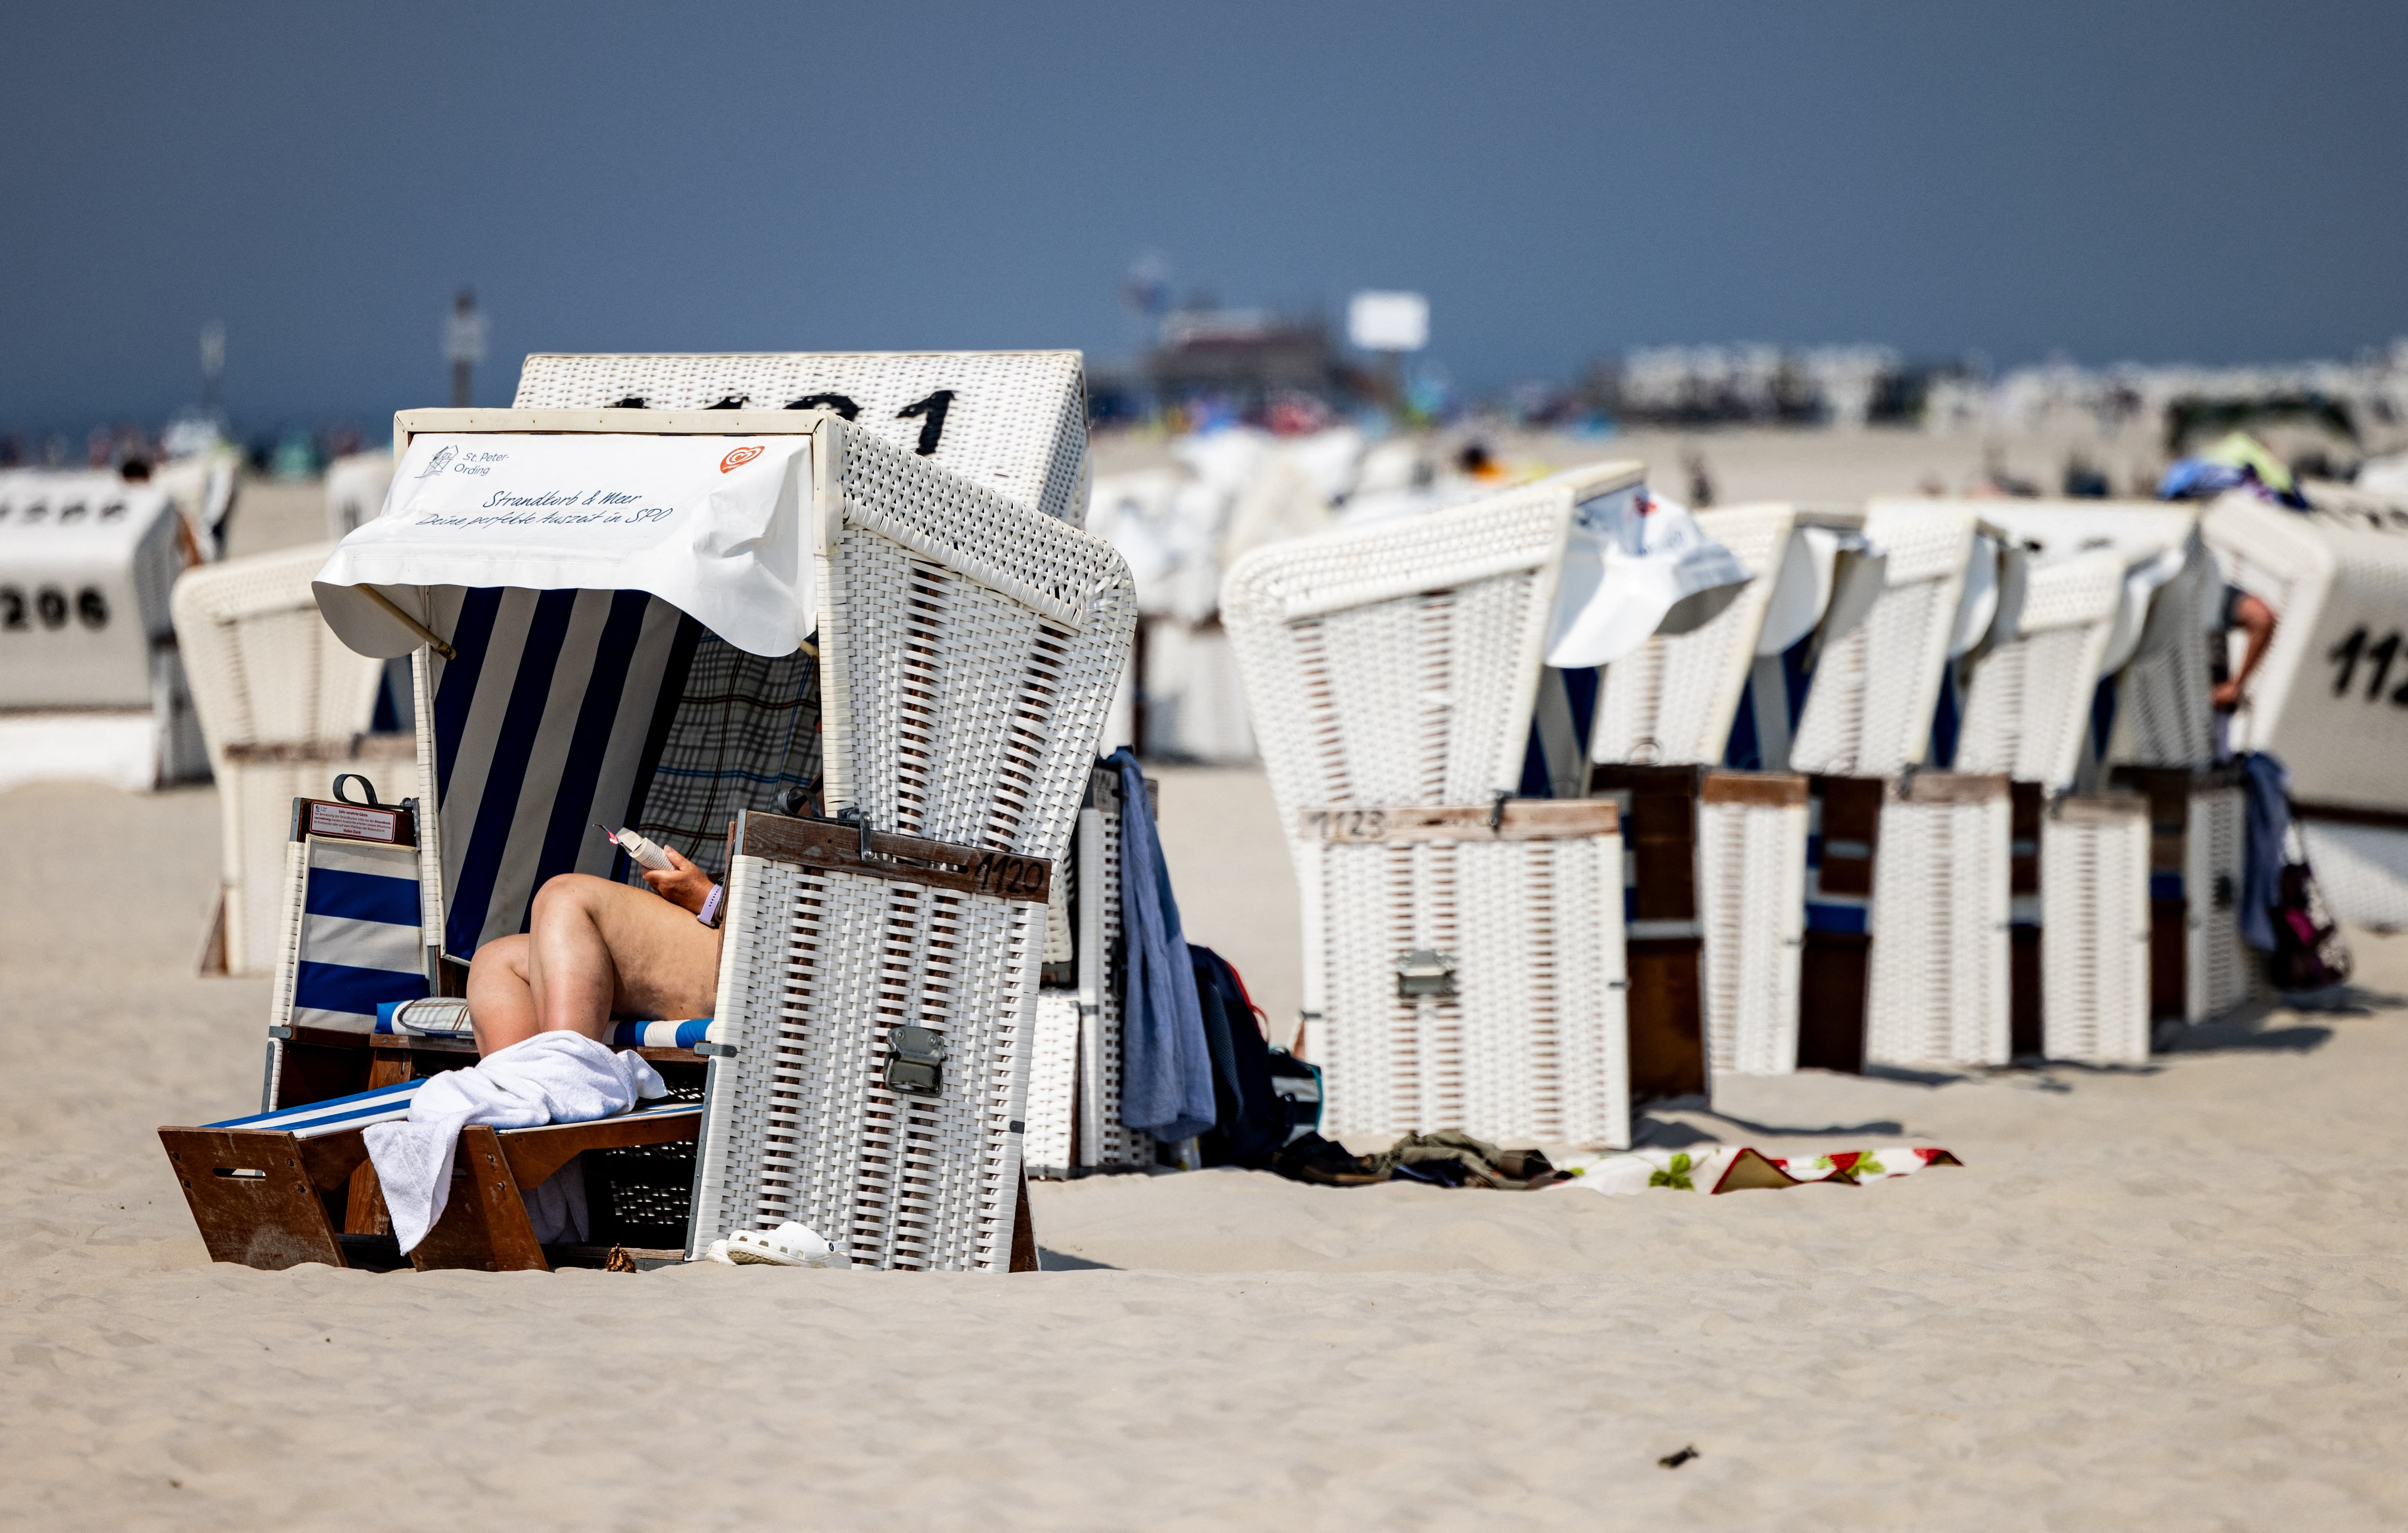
[{"left": 173, "top": 544, "right": 388, "bottom": 974}]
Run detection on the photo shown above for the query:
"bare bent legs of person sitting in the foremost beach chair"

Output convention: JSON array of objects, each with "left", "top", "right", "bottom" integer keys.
[{"left": 467, "top": 873, "right": 720, "bottom": 1054}]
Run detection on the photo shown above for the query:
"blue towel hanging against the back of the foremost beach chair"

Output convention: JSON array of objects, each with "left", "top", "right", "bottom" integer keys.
[{"left": 1105, "top": 746, "right": 1216, "bottom": 1143}]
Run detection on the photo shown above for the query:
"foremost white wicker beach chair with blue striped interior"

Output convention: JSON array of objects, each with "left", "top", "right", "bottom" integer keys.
[{"left": 170, "top": 359, "right": 1132, "bottom": 1268}]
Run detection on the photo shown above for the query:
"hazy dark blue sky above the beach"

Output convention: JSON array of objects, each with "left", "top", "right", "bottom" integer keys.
[{"left": 0, "top": 0, "right": 2408, "bottom": 429}]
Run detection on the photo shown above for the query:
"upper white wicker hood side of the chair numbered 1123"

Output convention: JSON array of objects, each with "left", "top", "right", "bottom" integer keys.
[{"left": 1221, "top": 465, "right": 1635, "bottom": 825}]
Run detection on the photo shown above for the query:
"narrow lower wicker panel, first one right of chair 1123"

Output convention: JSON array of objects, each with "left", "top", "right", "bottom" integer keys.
[{"left": 1698, "top": 804, "right": 1808, "bottom": 1076}]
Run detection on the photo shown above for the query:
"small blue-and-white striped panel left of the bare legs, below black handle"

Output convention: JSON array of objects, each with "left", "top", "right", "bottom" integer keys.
[{"left": 291, "top": 840, "right": 426, "bottom": 1032}]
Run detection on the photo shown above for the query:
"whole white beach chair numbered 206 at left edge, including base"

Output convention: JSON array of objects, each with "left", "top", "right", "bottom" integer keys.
[{"left": 0, "top": 469, "right": 207, "bottom": 792}]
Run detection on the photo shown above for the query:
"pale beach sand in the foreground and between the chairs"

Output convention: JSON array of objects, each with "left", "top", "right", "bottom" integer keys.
[{"left": 0, "top": 775, "right": 2408, "bottom": 1531}]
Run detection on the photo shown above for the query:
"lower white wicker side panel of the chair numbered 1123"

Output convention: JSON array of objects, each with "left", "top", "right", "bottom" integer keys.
[{"left": 1317, "top": 818, "right": 1630, "bottom": 1145}]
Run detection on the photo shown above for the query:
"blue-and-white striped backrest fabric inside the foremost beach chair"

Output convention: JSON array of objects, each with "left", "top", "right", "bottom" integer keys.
[{"left": 426, "top": 587, "right": 703, "bottom": 958}]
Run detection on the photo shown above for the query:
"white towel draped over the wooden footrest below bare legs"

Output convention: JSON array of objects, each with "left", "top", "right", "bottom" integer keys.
[{"left": 361, "top": 1032, "right": 669, "bottom": 1251}]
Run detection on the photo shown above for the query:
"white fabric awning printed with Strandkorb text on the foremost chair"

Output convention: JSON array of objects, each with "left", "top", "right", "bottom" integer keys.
[{"left": 313, "top": 433, "right": 816, "bottom": 657}]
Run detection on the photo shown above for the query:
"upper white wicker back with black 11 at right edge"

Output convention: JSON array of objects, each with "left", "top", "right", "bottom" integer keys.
[{"left": 2206, "top": 498, "right": 2408, "bottom": 808}]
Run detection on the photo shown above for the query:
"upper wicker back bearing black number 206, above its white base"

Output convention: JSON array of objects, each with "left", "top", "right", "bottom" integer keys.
[{"left": 0, "top": 469, "right": 183, "bottom": 713}]
